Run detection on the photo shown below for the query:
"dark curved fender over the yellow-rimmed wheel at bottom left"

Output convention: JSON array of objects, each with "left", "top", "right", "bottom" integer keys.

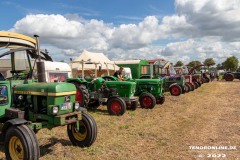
[{"left": 0, "top": 118, "right": 28, "bottom": 141}]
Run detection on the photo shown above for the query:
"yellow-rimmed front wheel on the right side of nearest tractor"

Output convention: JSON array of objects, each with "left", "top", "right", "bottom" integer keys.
[{"left": 67, "top": 112, "right": 97, "bottom": 147}]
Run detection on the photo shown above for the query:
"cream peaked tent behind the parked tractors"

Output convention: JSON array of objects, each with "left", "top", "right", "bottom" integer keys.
[{"left": 71, "top": 50, "right": 119, "bottom": 70}]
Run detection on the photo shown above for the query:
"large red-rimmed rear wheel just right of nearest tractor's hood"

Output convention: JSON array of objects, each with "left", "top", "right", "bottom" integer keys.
[{"left": 75, "top": 84, "right": 89, "bottom": 107}]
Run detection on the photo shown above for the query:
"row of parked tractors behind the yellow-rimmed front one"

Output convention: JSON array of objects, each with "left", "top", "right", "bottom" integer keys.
[{"left": 66, "top": 60, "right": 209, "bottom": 116}]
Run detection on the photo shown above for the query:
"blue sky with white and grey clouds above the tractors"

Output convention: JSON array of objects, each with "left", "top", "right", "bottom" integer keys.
[{"left": 0, "top": 0, "right": 240, "bottom": 64}]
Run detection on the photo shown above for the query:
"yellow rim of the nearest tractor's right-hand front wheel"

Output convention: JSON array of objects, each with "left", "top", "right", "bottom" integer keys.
[{"left": 72, "top": 121, "right": 87, "bottom": 141}]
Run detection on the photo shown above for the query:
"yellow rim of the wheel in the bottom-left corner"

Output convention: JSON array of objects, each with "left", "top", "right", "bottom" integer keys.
[{"left": 8, "top": 136, "right": 24, "bottom": 160}]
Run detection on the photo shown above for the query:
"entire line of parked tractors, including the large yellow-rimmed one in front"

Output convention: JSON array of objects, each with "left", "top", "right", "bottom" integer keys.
[{"left": 0, "top": 31, "right": 212, "bottom": 160}]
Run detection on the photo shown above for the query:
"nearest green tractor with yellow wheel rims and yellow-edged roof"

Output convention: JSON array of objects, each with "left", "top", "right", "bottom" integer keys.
[{"left": 0, "top": 32, "right": 97, "bottom": 160}]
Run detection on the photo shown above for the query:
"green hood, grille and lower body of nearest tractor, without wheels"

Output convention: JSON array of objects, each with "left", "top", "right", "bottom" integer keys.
[{"left": 0, "top": 81, "right": 81, "bottom": 130}]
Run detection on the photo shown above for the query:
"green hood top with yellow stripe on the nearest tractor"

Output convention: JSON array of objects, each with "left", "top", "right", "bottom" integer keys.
[{"left": 14, "top": 83, "right": 76, "bottom": 96}]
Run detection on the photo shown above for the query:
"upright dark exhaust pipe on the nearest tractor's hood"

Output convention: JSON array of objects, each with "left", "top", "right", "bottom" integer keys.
[{"left": 34, "top": 35, "right": 46, "bottom": 82}]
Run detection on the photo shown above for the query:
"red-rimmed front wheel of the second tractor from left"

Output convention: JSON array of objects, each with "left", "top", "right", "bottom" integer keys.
[{"left": 107, "top": 97, "right": 127, "bottom": 116}]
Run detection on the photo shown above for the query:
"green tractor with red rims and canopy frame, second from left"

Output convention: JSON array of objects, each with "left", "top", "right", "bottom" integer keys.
[{"left": 66, "top": 60, "right": 137, "bottom": 115}]
